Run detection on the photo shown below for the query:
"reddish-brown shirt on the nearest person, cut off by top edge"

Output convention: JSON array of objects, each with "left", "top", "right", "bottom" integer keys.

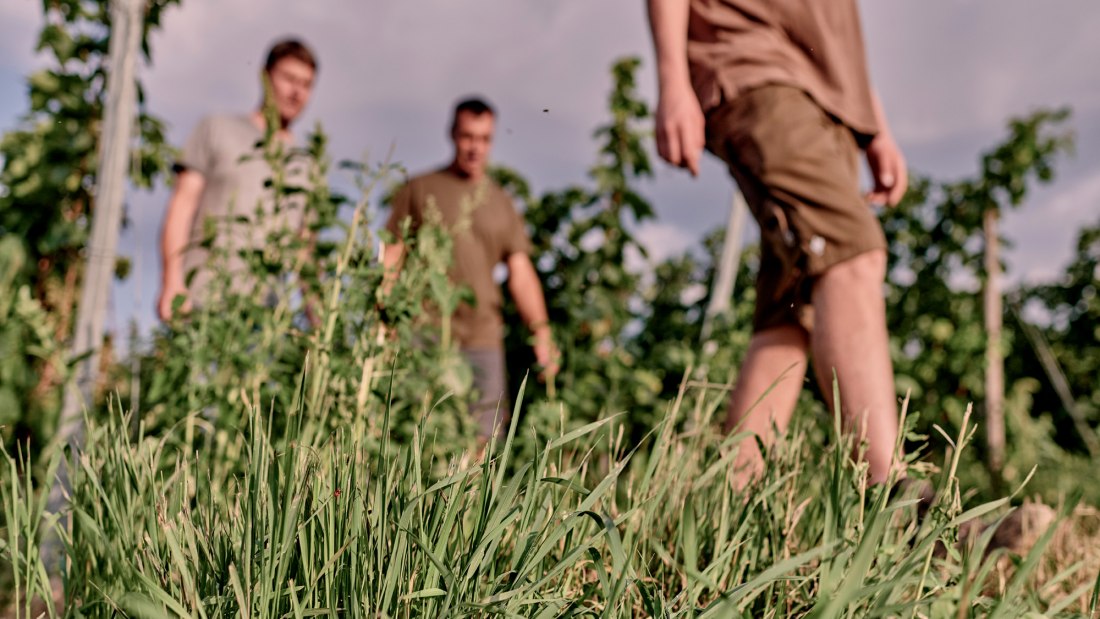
[{"left": 688, "top": 0, "right": 878, "bottom": 141}]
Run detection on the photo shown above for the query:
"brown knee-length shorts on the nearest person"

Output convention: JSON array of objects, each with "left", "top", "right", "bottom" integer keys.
[{"left": 706, "top": 86, "right": 887, "bottom": 331}]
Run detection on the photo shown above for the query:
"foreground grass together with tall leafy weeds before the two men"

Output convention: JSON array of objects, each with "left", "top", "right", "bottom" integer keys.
[{"left": 0, "top": 106, "right": 1100, "bottom": 619}]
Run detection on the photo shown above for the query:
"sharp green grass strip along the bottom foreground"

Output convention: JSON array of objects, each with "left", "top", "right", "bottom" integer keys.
[{"left": 0, "top": 365, "right": 1100, "bottom": 618}]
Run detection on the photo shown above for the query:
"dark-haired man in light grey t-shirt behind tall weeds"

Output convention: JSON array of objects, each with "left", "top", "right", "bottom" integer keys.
[{"left": 156, "top": 40, "right": 317, "bottom": 320}]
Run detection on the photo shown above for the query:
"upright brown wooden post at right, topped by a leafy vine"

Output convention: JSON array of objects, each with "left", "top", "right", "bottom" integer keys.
[{"left": 982, "top": 208, "right": 1004, "bottom": 483}]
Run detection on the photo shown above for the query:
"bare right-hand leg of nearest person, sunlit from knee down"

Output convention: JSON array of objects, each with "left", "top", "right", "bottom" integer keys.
[{"left": 813, "top": 250, "right": 898, "bottom": 484}]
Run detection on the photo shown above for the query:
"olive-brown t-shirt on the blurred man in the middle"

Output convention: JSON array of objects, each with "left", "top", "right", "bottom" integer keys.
[{"left": 386, "top": 168, "right": 530, "bottom": 350}]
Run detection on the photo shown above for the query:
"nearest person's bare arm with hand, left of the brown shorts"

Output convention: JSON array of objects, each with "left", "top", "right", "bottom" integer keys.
[{"left": 648, "top": 0, "right": 706, "bottom": 176}]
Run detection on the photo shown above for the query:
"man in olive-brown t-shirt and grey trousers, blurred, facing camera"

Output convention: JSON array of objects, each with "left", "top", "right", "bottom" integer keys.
[{"left": 384, "top": 99, "right": 558, "bottom": 441}]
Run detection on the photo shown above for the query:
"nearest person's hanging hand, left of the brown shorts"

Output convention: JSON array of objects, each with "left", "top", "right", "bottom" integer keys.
[{"left": 657, "top": 82, "right": 706, "bottom": 176}]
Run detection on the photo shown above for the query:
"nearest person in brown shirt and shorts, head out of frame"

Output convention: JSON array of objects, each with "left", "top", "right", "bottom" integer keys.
[{"left": 649, "top": 0, "right": 908, "bottom": 484}]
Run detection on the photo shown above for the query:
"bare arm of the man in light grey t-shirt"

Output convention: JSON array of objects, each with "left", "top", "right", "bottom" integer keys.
[{"left": 156, "top": 170, "right": 206, "bottom": 320}]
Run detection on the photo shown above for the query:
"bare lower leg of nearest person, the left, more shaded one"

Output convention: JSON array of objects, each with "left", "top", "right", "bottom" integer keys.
[{"left": 725, "top": 324, "right": 810, "bottom": 488}]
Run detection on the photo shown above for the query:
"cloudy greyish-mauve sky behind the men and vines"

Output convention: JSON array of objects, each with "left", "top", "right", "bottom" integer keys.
[{"left": 0, "top": 0, "right": 1100, "bottom": 343}]
